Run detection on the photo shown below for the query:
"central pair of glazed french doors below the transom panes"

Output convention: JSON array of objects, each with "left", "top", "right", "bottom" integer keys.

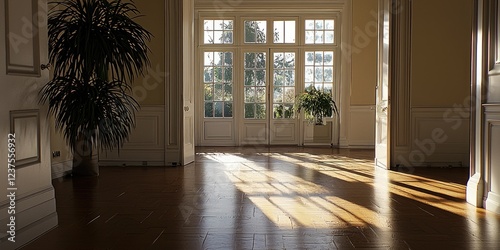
[{"left": 240, "top": 49, "right": 298, "bottom": 144}]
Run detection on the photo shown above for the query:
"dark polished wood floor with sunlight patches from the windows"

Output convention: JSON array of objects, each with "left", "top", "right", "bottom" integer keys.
[{"left": 23, "top": 147, "right": 500, "bottom": 250}]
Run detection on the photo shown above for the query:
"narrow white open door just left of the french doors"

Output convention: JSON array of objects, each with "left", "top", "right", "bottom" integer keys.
[{"left": 182, "top": 0, "right": 195, "bottom": 165}]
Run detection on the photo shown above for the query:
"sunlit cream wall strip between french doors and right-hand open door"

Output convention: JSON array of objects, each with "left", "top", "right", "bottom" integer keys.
[{"left": 351, "top": 0, "right": 378, "bottom": 106}]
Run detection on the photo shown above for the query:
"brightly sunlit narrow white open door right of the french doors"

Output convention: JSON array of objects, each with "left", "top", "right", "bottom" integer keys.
[{"left": 375, "top": 0, "right": 392, "bottom": 169}]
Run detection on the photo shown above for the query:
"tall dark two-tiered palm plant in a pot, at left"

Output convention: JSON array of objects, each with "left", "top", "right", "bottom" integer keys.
[{"left": 40, "top": 0, "right": 151, "bottom": 175}]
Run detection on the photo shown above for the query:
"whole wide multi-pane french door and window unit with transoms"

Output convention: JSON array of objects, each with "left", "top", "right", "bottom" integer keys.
[{"left": 196, "top": 13, "right": 340, "bottom": 146}]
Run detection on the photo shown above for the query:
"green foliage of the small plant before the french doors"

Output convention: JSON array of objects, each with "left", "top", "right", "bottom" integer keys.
[{"left": 294, "top": 86, "right": 338, "bottom": 125}]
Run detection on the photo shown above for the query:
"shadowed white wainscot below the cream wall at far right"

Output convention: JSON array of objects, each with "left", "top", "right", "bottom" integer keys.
[{"left": 408, "top": 108, "right": 470, "bottom": 166}]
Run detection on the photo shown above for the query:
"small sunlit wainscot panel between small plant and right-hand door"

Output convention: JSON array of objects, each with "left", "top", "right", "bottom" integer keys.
[{"left": 348, "top": 105, "right": 375, "bottom": 148}]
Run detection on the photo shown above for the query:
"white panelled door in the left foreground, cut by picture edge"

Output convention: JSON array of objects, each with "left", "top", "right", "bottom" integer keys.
[{"left": 0, "top": 0, "right": 57, "bottom": 249}]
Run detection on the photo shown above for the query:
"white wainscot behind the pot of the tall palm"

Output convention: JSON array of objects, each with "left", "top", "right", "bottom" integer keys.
[{"left": 99, "top": 106, "right": 165, "bottom": 166}]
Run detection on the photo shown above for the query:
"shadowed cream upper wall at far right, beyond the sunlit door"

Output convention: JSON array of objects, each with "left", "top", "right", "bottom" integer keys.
[{"left": 411, "top": 0, "right": 472, "bottom": 107}]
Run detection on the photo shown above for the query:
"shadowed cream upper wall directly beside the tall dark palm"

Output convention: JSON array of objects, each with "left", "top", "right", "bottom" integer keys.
[{"left": 132, "top": 0, "right": 167, "bottom": 105}]
